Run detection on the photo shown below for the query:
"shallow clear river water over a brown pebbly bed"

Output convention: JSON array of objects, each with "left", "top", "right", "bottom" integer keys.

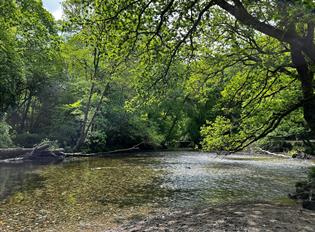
[{"left": 0, "top": 151, "right": 313, "bottom": 231}]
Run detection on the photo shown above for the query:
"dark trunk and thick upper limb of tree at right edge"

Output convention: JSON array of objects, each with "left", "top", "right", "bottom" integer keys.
[{"left": 218, "top": 0, "right": 315, "bottom": 138}]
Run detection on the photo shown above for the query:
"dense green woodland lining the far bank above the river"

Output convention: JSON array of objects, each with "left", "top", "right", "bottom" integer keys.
[{"left": 0, "top": 0, "right": 315, "bottom": 156}]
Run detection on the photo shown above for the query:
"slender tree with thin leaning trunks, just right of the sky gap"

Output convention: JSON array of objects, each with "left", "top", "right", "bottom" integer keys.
[{"left": 63, "top": 0, "right": 131, "bottom": 150}]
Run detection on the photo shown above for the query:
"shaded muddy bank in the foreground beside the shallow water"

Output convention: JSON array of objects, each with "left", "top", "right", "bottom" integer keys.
[{"left": 107, "top": 203, "right": 315, "bottom": 232}]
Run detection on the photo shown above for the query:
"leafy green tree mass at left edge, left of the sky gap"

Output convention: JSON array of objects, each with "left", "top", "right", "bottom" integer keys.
[{"left": 0, "top": 0, "right": 73, "bottom": 146}]
